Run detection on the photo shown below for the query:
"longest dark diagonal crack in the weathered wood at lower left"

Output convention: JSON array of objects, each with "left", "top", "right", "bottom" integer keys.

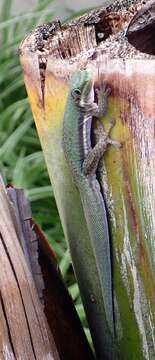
[{"left": 0, "top": 234, "right": 37, "bottom": 360}]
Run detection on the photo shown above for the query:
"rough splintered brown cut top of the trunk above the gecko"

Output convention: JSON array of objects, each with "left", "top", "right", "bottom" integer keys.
[{"left": 20, "top": 0, "right": 155, "bottom": 97}]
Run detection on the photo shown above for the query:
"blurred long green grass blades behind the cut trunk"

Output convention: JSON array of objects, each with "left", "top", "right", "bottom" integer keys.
[{"left": 0, "top": 0, "right": 90, "bottom": 338}]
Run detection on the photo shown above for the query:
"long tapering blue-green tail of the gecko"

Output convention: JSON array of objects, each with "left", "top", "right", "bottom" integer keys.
[{"left": 81, "top": 181, "right": 115, "bottom": 337}]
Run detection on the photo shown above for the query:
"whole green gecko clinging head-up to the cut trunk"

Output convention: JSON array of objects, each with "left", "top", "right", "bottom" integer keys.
[{"left": 63, "top": 70, "right": 120, "bottom": 336}]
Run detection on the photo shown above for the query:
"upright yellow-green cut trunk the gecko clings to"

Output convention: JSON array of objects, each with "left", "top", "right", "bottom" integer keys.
[{"left": 20, "top": 1, "right": 155, "bottom": 360}]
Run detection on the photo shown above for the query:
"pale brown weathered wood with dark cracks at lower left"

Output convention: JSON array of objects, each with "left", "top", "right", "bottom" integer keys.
[{"left": 0, "top": 180, "right": 59, "bottom": 360}]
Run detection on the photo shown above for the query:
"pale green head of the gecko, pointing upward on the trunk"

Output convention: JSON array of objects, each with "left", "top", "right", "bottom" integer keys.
[{"left": 71, "top": 70, "right": 93, "bottom": 103}]
